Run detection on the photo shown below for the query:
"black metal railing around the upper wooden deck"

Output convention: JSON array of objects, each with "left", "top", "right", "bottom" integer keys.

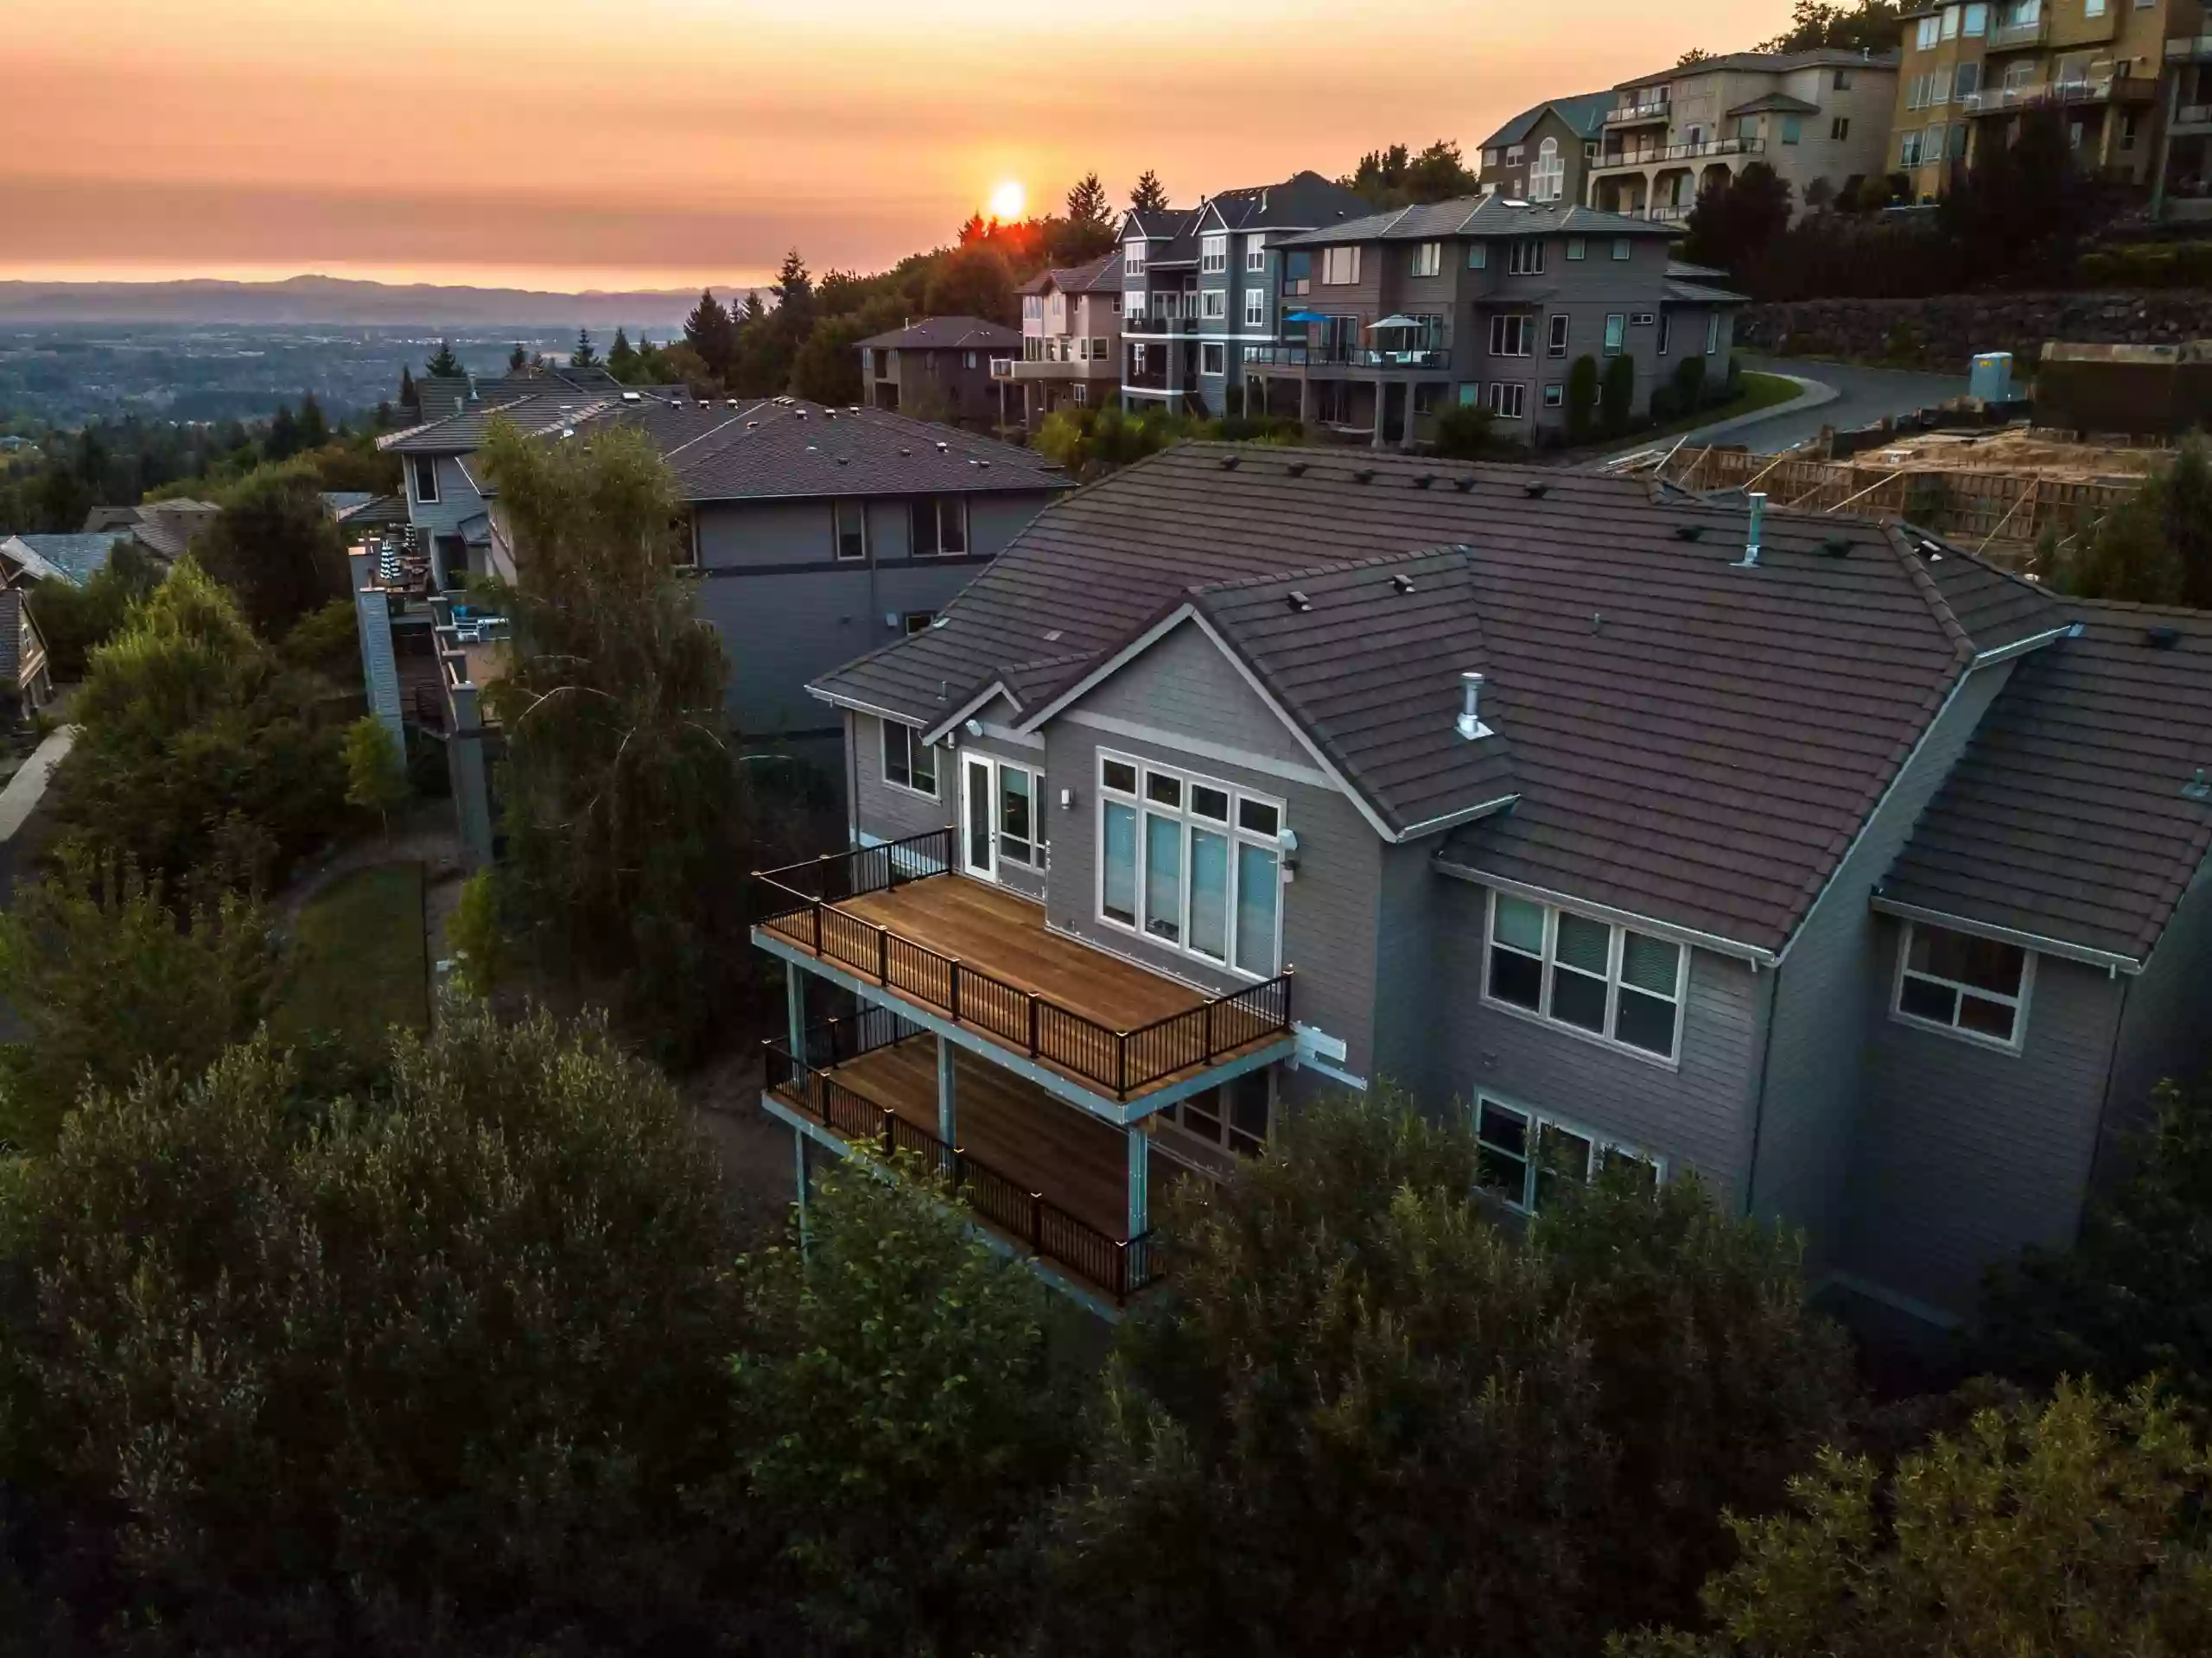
[{"left": 754, "top": 829, "right": 1292, "bottom": 1099}]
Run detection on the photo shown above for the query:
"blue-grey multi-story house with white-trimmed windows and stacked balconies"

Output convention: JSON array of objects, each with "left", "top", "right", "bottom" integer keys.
[{"left": 1122, "top": 173, "right": 1370, "bottom": 416}]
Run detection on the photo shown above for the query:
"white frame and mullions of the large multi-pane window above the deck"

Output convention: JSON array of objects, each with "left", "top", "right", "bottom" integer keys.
[{"left": 1090, "top": 747, "right": 1289, "bottom": 984}]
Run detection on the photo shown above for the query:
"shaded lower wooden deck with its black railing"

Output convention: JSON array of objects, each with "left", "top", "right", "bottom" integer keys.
[{"left": 766, "top": 1008, "right": 1159, "bottom": 1305}]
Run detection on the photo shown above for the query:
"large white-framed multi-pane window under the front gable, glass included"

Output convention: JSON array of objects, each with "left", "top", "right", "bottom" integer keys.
[{"left": 1097, "top": 749, "right": 1283, "bottom": 979}]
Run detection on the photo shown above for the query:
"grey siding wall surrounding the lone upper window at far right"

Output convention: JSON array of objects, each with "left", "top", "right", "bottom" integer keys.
[{"left": 1842, "top": 919, "right": 2119, "bottom": 1318}]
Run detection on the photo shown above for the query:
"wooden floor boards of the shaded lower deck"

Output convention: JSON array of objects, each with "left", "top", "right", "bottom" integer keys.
[{"left": 830, "top": 1037, "right": 1128, "bottom": 1240}]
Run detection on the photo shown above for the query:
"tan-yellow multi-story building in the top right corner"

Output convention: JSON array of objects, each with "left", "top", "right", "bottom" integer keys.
[{"left": 1889, "top": 0, "right": 2212, "bottom": 201}]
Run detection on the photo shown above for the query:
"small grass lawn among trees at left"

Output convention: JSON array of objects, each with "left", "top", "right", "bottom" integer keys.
[{"left": 270, "top": 864, "right": 429, "bottom": 1061}]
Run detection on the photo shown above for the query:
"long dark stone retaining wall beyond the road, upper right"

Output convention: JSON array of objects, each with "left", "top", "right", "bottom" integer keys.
[{"left": 1737, "top": 289, "right": 2212, "bottom": 373}]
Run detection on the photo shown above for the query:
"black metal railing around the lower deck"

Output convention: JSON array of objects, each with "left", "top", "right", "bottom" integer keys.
[{"left": 766, "top": 1039, "right": 1159, "bottom": 1305}]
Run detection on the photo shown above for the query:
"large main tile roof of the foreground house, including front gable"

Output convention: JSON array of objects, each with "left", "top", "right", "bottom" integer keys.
[{"left": 817, "top": 444, "right": 2013, "bottom": 950}]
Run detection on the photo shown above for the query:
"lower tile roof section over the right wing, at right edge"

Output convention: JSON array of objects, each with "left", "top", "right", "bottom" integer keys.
[{"left": 1883, "top": 599, "right": 2212, "bottom": 962}]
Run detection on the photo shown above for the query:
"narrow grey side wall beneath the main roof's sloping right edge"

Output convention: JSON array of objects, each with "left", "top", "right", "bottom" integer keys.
[{"left": 1750, "top": 664, "right": 2013, "bottom": 1271}]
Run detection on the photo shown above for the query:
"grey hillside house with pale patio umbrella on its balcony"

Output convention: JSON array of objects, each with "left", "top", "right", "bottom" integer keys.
[{"left": 1243, "top": 194, "right": 1741, "bottom": 448}]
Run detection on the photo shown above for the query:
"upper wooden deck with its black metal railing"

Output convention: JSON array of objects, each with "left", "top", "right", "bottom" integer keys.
[{"left": 752, "top": 829, "right": 1294, "bottom": 1121}]
